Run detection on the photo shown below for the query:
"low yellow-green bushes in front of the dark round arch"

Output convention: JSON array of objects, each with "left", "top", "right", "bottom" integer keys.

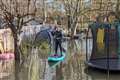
[{"left": 20, "top": 39, "right": 50, "bottom": 56}]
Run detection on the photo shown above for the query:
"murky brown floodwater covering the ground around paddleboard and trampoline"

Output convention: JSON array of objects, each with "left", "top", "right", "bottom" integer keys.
[{"left": 0, "top": 40, "right": 120, "bottom": 80}]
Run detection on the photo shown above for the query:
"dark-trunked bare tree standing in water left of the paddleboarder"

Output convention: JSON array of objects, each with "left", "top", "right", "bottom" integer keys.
[{"left": 0, "top": 0, "right": 37, "bottom": 60}]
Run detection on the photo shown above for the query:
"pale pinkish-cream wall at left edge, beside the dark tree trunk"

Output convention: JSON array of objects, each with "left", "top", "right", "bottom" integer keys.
[{"left": 0, "top": 29, "right": 14, "bottom": 53}]
